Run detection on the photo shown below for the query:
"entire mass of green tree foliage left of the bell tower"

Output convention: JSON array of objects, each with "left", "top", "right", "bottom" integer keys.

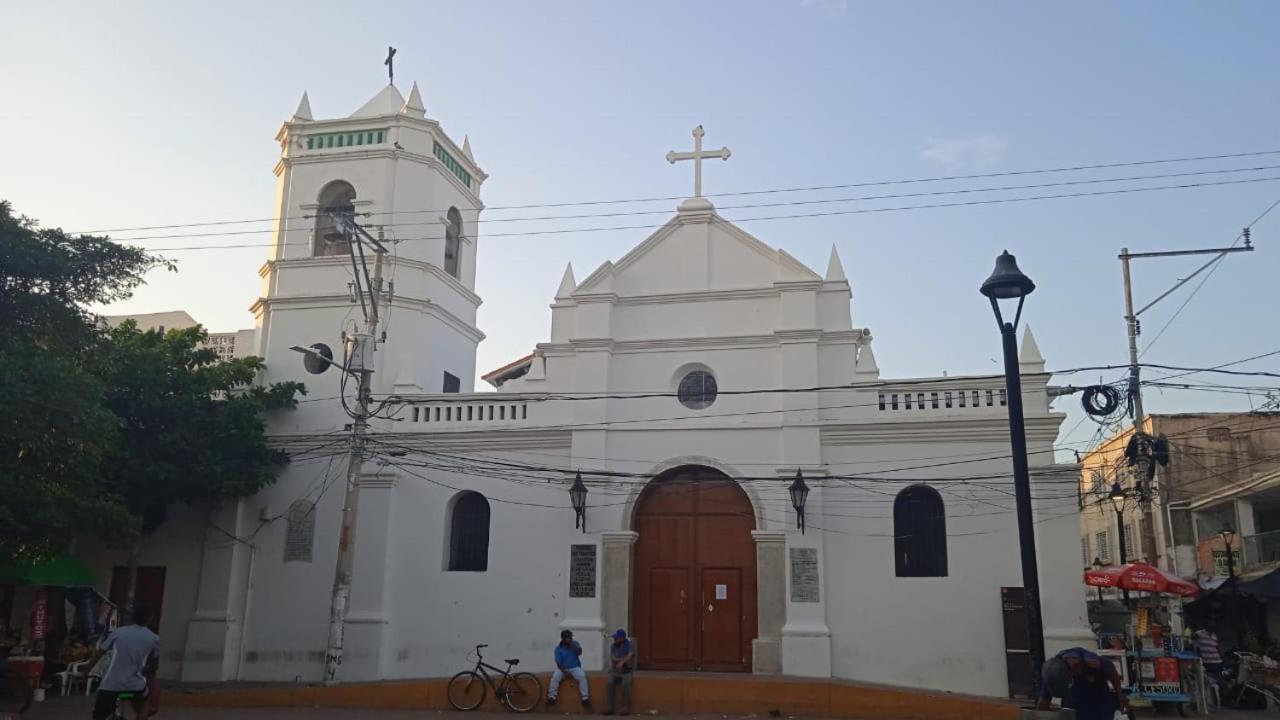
[{"left": 0, "top": 201, "right": 302, "bottom": 559}]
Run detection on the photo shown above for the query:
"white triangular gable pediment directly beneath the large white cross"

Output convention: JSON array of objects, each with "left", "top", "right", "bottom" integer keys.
[{"left": 573, "top": 204, "right": 822, "bottom": 297}]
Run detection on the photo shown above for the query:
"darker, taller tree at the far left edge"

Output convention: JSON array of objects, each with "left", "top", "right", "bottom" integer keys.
[{"left": 0, "top": 201, "right": 164, "bottom": 559}]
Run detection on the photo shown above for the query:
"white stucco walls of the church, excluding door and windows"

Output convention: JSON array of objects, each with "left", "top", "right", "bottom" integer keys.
[{"left": 135, "top": 83, "right": 1084, "bottom": 696}]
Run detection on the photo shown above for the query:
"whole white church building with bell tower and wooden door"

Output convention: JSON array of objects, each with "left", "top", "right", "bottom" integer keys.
[{"left": 100, "top": 78, "right": 1091, "bottom": 696}]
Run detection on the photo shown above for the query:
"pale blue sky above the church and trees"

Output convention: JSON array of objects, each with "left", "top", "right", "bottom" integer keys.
[{"left": 0, "top": 0, "right": 1280, "bottom": 453}]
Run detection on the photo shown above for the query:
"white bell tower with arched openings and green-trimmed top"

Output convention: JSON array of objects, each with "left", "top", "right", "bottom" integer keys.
[{"left": 252, "top": 83, "right": 488, "bottom": 420}]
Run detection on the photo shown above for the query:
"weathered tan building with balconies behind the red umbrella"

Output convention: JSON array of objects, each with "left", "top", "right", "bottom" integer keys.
[{"left": 1080, "top": 413, "right": 1280, "bottom": 592}]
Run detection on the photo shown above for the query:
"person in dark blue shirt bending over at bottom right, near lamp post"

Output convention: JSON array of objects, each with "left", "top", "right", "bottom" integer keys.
[{"left": 1037, "top": 647, "right": 1129, "bottom": 720}]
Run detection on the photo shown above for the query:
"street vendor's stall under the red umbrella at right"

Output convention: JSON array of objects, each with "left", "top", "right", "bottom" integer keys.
[{"left": 1084, "top": 562, "right": 1207, "bottom": 714}]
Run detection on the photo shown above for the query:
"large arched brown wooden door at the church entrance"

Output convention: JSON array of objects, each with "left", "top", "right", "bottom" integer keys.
[{"left": 632, "top": 466, "right": 756, "bottom": 671}]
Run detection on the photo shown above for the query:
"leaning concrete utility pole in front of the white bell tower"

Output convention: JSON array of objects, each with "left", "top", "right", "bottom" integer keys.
[{"left": 324, "top": 213, "right": 387, "bottom": 685}]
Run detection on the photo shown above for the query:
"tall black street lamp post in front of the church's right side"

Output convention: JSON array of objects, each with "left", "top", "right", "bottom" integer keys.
[{"left": 982, "top": 250, "right": 1044, "bottom": 692}]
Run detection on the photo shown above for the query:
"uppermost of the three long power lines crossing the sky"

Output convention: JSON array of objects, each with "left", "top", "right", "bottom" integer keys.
[{"left": 70, "top": 150, "right": 1280, "bottom": 234}]
